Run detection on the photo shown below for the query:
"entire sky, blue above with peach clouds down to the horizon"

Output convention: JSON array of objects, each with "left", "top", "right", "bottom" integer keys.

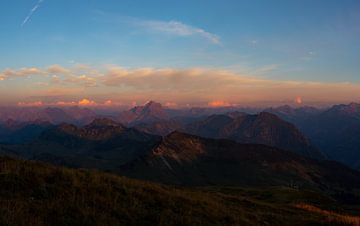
[{"left": 0, "top": 0, "right": 360, "bottom": 107}]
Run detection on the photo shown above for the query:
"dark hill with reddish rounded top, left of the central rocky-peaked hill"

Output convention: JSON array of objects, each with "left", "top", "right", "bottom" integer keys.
[{"left": 14, "top": 118, "right": 160, "bottom": 171}]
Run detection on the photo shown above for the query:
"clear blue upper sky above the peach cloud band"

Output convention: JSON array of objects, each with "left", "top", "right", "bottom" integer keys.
[{"left": 0, "top": 0, "right": 360, "bottom": 107}]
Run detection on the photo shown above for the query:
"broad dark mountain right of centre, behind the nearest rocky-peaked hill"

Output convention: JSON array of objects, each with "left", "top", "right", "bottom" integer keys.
[{"left": 185, "top": 112, "right": 324, "bottom": 159}]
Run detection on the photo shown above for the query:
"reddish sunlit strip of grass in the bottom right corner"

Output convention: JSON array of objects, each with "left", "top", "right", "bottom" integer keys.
[{"left": 295, "top": 203, "right": 360, "bottom": 226}]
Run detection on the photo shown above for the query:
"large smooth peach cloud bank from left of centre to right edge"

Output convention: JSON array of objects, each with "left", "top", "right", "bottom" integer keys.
[{"left": 101, "top": 67, "right": 360, "bottom": 105}]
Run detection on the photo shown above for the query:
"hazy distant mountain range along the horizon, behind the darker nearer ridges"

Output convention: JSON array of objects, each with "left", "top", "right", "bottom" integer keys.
[{"left": 0, "top": 101, "right": 360, "bottom": 168}]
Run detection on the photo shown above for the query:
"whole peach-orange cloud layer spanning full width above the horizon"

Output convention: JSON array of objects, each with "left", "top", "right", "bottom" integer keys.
[{"left": 0, "top": 65, "right": 360, "bottom": 107}]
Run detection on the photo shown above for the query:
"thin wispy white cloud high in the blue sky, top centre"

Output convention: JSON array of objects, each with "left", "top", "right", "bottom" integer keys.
[{"left": 135, "top": 20, "right": 220, "bottom": 44}]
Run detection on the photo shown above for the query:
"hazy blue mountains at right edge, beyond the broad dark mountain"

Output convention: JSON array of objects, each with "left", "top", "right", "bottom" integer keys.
[{"left": 267, "top": 103, "right": 360, "bottom": 168}]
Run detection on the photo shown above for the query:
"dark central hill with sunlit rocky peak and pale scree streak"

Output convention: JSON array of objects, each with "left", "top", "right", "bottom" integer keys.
[{"left": 122, "top": 132, "right": 360, "bottom": 194}]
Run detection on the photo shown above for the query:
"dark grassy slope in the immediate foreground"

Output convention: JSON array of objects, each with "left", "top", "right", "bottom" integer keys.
[{"left": 0, "top": 158, "right": 357, "bottom": 225}]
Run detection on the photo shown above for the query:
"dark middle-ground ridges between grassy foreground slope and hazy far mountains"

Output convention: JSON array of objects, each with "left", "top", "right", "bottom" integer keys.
[{"left": 1, "top": 118, "right": 360, "bottom": 196}]
